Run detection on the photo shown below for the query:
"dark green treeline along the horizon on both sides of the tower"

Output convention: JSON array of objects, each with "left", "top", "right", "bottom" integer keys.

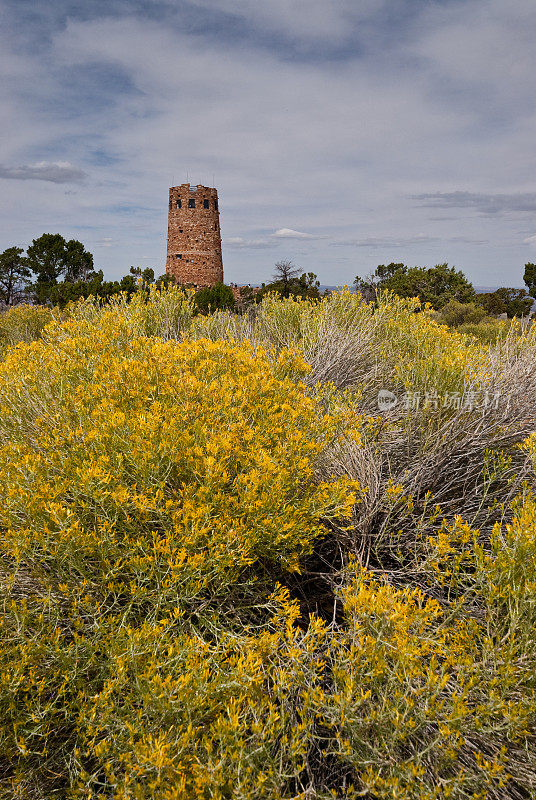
[{"left": 0, "top": 233, "right": 536, "bottom": 318}]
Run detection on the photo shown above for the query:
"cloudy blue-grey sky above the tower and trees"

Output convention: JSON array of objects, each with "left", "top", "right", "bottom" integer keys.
[{"left": 0, "top": 0, "right": 536, "bottom": 286}]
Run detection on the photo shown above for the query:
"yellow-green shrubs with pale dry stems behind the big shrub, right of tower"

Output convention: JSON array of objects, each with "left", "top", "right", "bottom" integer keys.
[{"left": 191, "top": 289, "right": 486, "bottom": 393}]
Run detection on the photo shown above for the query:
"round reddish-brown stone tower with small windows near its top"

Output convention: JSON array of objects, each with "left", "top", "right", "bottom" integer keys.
[{"left": 166, "top": 183, "right": 223, "bottom": 286}]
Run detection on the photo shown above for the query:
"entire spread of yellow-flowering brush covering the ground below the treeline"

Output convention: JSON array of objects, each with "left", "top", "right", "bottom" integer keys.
[{"left": 0, "top": 287, "right": 536, "bottom": 800}]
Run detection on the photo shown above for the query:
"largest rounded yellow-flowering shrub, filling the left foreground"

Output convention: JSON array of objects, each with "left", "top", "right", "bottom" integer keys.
[{"left": 0, "top": 311, "right": 356, "bottom": 793}]
